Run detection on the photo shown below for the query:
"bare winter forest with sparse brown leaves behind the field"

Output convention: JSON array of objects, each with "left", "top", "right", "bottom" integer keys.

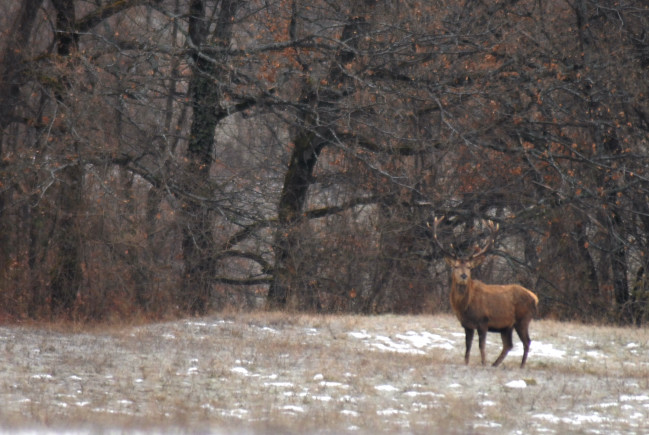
[{"left": 0, "top": 0, "right": 649, "bottom": 324}]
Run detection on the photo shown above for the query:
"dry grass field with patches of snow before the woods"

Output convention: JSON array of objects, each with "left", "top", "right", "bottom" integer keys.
[{"left": 0, "top": 313, "right": 649, "bottom": 434}]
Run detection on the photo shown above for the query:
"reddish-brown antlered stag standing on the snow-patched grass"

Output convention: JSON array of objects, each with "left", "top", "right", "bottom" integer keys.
[{"left": 429, "top": 217, "right": 539, "bottom": 369}]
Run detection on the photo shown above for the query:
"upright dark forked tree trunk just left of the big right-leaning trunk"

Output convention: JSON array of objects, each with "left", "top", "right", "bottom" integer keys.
[{"left": 178, "top": 0, "right": 239, "bottom": 314}]
